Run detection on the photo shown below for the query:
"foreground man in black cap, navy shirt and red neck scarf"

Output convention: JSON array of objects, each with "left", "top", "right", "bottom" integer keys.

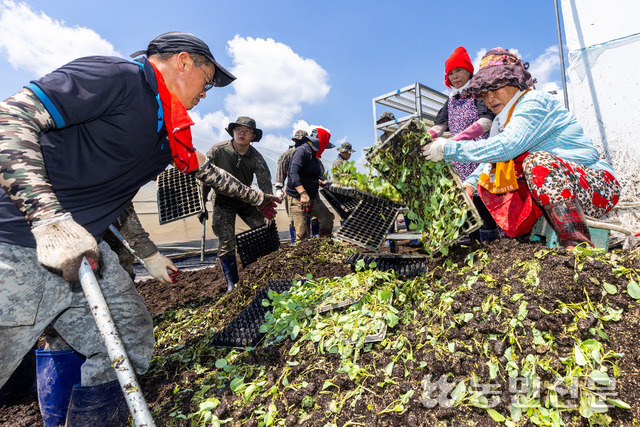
[{"left": 0, "top": 32, "right": 276, "bottom": 426}]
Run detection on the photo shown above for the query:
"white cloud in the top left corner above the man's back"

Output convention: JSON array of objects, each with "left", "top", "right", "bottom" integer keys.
[{"left": 0, "top": 0, "right": 120, "bottom": 76}]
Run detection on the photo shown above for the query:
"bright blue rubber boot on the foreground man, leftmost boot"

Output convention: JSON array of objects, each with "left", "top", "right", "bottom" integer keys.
[{"left": 35, "top": 348, "right": 84, "bottom": 427}]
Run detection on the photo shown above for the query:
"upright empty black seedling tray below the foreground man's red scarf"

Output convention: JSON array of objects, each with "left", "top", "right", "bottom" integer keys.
[{"left": 156, "top": 167, "right": 204, "bottom": 225}]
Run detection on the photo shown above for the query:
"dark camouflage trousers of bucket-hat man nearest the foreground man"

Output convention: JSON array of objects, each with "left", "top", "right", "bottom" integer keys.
[{"left": 211, "top": 205, "right": 265, "bottom": 257}]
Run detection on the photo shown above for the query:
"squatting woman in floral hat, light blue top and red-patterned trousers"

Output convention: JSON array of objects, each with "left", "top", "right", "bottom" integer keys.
[{"left": 423, "top": 48, "right": 621, "bottom": 247}]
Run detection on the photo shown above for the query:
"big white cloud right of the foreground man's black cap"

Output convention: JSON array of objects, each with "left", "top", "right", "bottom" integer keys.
[{"left": 225, "top": 35, "right": 330, "bottom": 129}]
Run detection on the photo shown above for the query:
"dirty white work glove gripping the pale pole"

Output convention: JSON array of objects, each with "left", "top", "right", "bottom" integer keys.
[{"left": 31, "top": 213, "right": 100, "bottom": 282}]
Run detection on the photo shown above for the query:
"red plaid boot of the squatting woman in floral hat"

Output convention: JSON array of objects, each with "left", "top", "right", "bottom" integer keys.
[{"left": 544, "top": 197, "right": 593, "bottom": 249}]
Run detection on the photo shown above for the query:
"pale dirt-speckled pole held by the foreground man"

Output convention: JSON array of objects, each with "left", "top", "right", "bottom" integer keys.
[{"left": 78, "top": 258, "right": 155, "bottom": 427}]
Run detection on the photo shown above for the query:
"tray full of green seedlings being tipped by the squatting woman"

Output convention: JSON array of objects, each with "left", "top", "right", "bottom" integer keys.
[{"left": 367, "top": 119, "right": 482, "bottom": 256}]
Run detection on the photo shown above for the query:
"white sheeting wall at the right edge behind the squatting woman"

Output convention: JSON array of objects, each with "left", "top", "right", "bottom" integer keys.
[{"left": 562, "top": 0, "right": 640, "bottom": 231}]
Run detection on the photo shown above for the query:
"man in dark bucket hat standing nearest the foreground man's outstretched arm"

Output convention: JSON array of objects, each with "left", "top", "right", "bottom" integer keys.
[{"left": 203, "top": 116, "right": 276, "bottom": 292}]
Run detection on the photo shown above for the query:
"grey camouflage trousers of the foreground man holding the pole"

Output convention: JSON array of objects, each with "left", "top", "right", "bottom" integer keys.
[{"left": 0, "top": 242, "right": 154, "bottom": 387}]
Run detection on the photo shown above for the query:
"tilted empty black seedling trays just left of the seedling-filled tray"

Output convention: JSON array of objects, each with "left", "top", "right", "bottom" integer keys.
[{"left": 331, "top": 185, "right": 402, "bottom": 251}]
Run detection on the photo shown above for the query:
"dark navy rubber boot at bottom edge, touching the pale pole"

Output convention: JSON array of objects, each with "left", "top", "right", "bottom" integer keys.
[{"left": 66, "top": 380, "right": 129, "bottom": 427}]
